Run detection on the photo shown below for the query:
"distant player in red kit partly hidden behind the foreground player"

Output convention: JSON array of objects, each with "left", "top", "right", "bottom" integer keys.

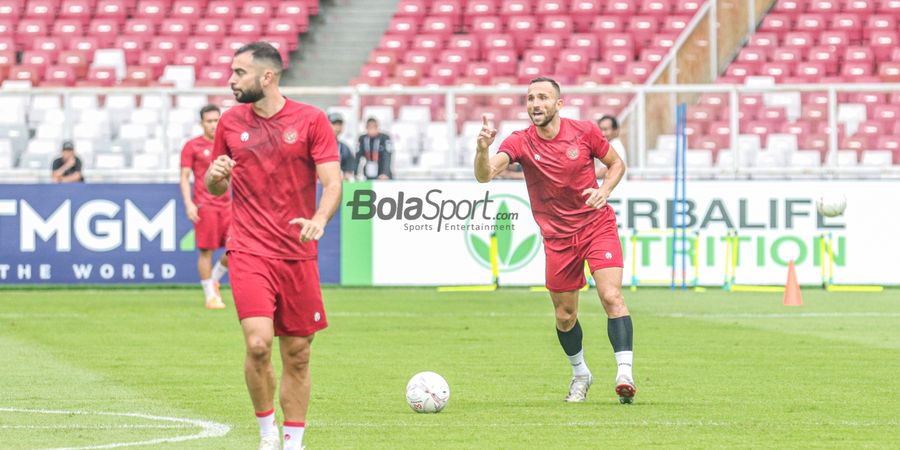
[{"left": 181, "top": 105, "right": 231, "bottom": 309}]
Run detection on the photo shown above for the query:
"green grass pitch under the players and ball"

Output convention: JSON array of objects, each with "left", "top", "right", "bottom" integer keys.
[{"left": 0, "top": 288, "right": 900, "bottom": 449}]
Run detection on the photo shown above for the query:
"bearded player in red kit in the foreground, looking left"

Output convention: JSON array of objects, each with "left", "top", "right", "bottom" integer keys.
[{"left": 206, "top": 42, "right": 341, "bottom": 450}]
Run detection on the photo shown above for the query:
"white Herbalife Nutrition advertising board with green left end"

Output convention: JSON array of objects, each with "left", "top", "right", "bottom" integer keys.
[{"left": 341, "top": 181, "right": 900, "bottom": 285}]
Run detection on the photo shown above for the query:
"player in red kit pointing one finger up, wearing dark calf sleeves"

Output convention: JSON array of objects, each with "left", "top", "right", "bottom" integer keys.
[{"left": 475, "top": 77, "right": 635, "bottom": 403}]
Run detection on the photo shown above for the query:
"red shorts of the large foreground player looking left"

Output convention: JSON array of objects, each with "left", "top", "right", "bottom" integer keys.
[{"left": 228, "top": 251, "right": 328, "bottom": 336}]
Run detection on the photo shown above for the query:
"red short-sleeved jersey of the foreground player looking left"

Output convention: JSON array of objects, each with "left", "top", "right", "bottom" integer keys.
[{"left": 213, "top": 98, "right": 339, "bottom": 259}]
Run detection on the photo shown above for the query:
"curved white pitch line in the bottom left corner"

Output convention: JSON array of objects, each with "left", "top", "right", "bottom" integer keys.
[{"left": 0, "top": 407, "right": 231, "bottom": 450}]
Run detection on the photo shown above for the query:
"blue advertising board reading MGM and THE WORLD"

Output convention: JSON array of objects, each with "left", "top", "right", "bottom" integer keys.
[{"left": 0, "top": 183, "right": 340, "bottom": 284}]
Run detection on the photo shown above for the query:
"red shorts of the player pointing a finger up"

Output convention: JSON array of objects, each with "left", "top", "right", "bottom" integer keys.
[{"left": 544, "top": 221, "right": 623, "bottom": 292}]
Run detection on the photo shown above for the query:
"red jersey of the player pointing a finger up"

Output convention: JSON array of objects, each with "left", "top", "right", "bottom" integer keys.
[{"left": 500, "top": 118, "right": 616, "bottom": 238}]
